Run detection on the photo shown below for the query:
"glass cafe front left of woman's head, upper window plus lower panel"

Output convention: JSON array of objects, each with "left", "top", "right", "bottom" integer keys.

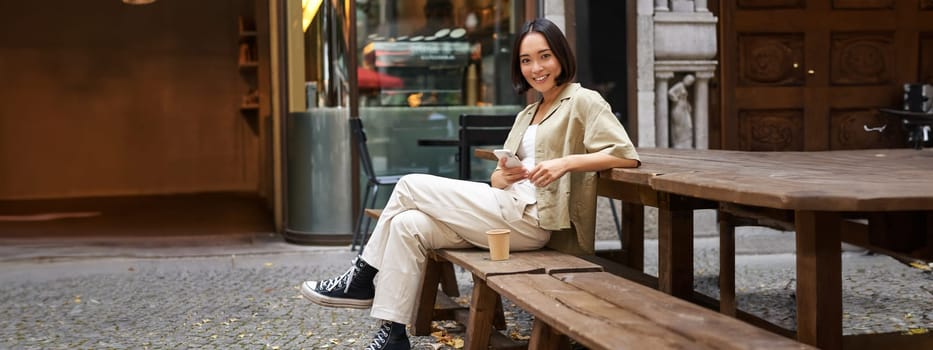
[{"left": 356, "top": 0, "right": 524, "bottom": 173}]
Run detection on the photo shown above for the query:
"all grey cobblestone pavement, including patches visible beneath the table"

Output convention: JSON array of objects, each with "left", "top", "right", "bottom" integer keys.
[{"left": 0, "top": 206, "right": 933, "bottom": 349}]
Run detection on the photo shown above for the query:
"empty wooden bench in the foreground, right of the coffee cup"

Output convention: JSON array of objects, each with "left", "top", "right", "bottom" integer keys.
[{"left": 486, "top": 272, "right": 813, "bottom": 349}]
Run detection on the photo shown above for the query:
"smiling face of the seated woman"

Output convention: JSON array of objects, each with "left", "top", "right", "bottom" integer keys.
[{"left": 518, "top": 32, "right": 561, "bottom": 96}]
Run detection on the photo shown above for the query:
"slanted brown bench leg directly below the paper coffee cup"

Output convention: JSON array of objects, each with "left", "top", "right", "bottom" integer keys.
[{"left": 465, "top": 275, "right": 499, "bottom": 350}]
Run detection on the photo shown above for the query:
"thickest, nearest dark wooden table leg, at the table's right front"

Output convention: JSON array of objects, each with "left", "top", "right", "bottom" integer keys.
[{"left": 796, "top": 211, "right": 842, "bottom": 349}]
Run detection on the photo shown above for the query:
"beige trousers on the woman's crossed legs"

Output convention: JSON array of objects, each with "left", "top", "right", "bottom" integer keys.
[{"left": 362, "top": 174, "right": 551, "bottom": 324}]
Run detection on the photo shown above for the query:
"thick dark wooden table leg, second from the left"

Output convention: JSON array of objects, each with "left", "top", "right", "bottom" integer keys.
[{"left": 658, "top": 193, "right": 693, "bottom": 299}]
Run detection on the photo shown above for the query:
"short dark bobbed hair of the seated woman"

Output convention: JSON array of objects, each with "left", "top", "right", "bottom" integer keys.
[{"left": 512, "top": 18, "right": 577, "bottom": 94}]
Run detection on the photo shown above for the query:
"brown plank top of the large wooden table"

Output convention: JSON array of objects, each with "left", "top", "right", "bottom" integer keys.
[{"left": 600, "top": 148, "right": 933, "bottom": 211}]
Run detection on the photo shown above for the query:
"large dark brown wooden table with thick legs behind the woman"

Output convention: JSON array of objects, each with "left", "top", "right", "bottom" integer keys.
[{"left": 599, "top": 148, "right": 933, "bottom": 349}]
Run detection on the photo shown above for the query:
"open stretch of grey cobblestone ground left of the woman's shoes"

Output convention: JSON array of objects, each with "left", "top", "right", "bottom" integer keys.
[{"left": 0, "top": 249, "right": 436, "bottom": 349}]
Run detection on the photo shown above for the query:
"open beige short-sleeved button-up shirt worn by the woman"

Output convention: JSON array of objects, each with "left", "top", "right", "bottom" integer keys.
[{"left": 504, "top": 83, "right": 640, "bottom": 254}]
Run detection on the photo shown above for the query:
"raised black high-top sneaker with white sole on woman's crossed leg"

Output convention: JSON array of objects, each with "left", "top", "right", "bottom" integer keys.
[{"left": 301, "top": 256, "right": 379, "bottom": 309}]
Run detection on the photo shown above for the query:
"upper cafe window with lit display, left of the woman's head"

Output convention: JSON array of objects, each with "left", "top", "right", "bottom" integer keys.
[{"left": 356, "top": 0, "right": 523, "bottom": 107}]
